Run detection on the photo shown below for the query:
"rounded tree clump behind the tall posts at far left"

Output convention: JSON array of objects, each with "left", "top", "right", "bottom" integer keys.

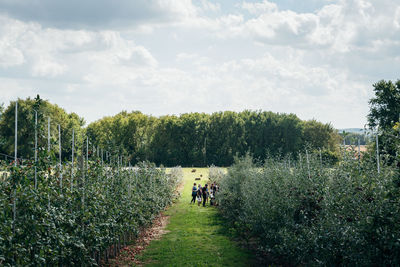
[{"left": 0, "top": 96, "right": 85, "bottom": 159}]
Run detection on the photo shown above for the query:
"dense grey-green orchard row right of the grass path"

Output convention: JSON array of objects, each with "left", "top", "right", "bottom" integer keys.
[{"left": 219, "top": 153, "right": 400, "bottom": 266}]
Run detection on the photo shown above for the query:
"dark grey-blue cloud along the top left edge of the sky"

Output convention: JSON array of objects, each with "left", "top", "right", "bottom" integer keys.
[{"left": 0, "top": 0, "right": 199, "bottom": 29}]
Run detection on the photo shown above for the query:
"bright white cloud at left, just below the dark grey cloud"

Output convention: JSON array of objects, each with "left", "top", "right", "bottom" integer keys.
[{"left": 0, "top": 16, "right": 158, "bottom": 79}]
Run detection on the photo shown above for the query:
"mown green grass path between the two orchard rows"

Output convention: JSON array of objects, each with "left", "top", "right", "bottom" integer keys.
[{"left": 139, "top": 168, "right": 254, "bottom": 266}]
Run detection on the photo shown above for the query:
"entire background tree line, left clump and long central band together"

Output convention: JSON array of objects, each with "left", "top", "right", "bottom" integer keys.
[{"left": 0, "top": 96, "right": 340, "bottom": 166}]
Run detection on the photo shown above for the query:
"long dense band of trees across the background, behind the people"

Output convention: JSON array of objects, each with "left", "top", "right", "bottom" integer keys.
[{"left": 87, "top": 111, "right": 339, "bottom": 166}]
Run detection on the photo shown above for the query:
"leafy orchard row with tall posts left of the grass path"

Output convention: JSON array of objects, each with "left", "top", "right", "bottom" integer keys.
[{"left": 0, "top": 154, "right": 180, "bottom": 266}]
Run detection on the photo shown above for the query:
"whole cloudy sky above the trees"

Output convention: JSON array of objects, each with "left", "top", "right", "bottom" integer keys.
[{"left": 0, "top": 0, "right": 400, "bottom": 129}]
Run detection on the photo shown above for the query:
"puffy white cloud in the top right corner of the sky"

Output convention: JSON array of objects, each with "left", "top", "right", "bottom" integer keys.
[{"left": 231, "top": 0, "right": 400, "bottom": 53}]
